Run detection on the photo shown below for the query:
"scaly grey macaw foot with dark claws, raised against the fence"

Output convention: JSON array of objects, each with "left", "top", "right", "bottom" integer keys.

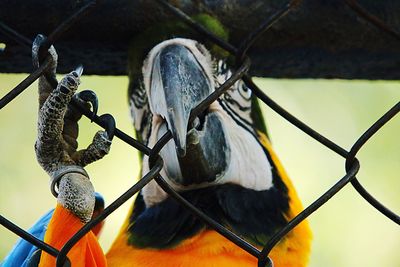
[{"left": 35, "top": 67, "right": 115, "bottom": 222}]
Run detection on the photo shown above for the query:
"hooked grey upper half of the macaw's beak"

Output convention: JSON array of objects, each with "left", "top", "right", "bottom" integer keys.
[{"left": 150, "top": 44, "right": 212, "bottom": 157}]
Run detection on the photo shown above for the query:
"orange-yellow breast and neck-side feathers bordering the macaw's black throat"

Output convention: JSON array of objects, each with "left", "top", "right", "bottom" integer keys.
[{"left": 106, "top": 133, "right": 311, "bottom": 267}]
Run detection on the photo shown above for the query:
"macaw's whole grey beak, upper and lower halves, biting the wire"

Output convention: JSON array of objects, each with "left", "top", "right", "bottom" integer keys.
[{"left": 143, "top": 39, "right": 230, "bottom": 188}]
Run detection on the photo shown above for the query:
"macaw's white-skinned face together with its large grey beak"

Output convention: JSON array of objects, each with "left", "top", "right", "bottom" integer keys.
[{"left": 130, "top": 38, "right": 272, "bottom": 205}]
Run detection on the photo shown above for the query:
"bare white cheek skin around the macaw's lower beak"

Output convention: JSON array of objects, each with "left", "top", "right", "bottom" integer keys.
[{"left": 142, "top": 102, "right": 273, "bottom": 206}]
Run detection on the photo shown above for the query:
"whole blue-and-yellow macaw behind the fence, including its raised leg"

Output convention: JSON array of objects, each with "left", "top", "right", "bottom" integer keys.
[{"left": 1, "top": 15, "right": 311, "bottom": 267}]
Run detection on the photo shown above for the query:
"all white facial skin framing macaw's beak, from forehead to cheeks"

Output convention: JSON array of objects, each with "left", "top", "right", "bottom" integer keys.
[{"left": 135, "top": 38, "right": 273, "bottom": 206}]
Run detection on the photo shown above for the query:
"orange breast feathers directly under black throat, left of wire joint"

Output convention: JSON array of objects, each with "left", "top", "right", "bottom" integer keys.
[{"left": 106, "top": 231, "right": 258, "bottom": 267}]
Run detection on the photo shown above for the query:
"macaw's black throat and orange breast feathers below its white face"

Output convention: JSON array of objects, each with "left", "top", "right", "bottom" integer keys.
[{"left": 107, "top": 132, "right": 312, "bottom": 267}]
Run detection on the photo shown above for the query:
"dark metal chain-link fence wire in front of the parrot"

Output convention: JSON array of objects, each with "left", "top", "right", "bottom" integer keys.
[{"left": 0, "top": 0, "right": 400, "bottom": 266}]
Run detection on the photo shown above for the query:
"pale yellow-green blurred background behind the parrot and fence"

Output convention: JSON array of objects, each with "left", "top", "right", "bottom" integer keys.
[{"left": 0, "top": 74, "right": 400, "bottom": 267}]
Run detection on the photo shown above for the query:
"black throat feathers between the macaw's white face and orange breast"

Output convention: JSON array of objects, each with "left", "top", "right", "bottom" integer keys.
[{"left": 127, "top": 161, "right": 289, "bottom": 249}]
